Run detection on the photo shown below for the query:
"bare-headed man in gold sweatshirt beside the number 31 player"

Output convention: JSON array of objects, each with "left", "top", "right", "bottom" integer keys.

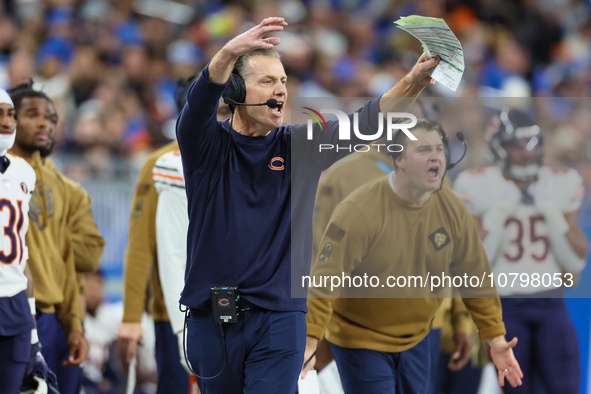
[{"left": 10, "top": 81, "right": 104, "bottom": 393}]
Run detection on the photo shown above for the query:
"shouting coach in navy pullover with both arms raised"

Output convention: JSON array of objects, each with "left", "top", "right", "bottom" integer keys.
[{"left": 177, "top": 17, "right": 439, "bottom": 394}]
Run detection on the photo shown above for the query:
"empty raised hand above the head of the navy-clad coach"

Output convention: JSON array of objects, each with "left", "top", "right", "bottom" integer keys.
[{"left": 223, "top": 17, "right": 287, "bottom": 57}]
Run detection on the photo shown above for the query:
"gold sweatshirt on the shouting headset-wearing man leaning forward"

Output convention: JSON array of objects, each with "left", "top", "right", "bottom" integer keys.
[{"left": 306, "top": 175, "right": 505, "bottom": 352}]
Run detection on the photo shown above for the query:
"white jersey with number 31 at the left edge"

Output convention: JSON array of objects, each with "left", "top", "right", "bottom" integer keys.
[{"left": 0, "top": 154, "right": 35, "bottom": 297}]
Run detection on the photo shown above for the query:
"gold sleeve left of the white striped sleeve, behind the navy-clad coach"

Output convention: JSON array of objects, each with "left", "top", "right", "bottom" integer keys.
[{"left": 123, "top": 141, "right": 179, "bottom": 323}]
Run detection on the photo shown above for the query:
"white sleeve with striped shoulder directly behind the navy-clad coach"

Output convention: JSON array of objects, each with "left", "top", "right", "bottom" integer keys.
[{"left": 152, "top": 150, "right": 189, "bottom": 334}]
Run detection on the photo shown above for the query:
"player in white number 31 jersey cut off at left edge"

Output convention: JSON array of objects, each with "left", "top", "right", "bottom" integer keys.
[{"left": 0, "top": 89, "right": 56, "bottom": 393}]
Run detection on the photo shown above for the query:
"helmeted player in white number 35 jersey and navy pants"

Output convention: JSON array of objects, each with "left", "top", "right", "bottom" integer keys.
[{"left": 454, "top": 108, "right": 587, "bottom": 394}]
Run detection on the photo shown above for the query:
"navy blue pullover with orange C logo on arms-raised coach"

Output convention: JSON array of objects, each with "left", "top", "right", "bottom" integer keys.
[{"left": 176, "top": 67, "right": 385, "bottom": 312}]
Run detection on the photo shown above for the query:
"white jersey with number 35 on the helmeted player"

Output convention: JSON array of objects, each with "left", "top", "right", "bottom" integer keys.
[{"left": 454, "top": 167, "right": 584, "bottom": 296}]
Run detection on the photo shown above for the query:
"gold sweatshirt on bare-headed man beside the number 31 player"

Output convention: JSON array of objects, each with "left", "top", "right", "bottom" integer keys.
[{"left": 13, "top": 153, "right": 104, "bottom": 334}]
